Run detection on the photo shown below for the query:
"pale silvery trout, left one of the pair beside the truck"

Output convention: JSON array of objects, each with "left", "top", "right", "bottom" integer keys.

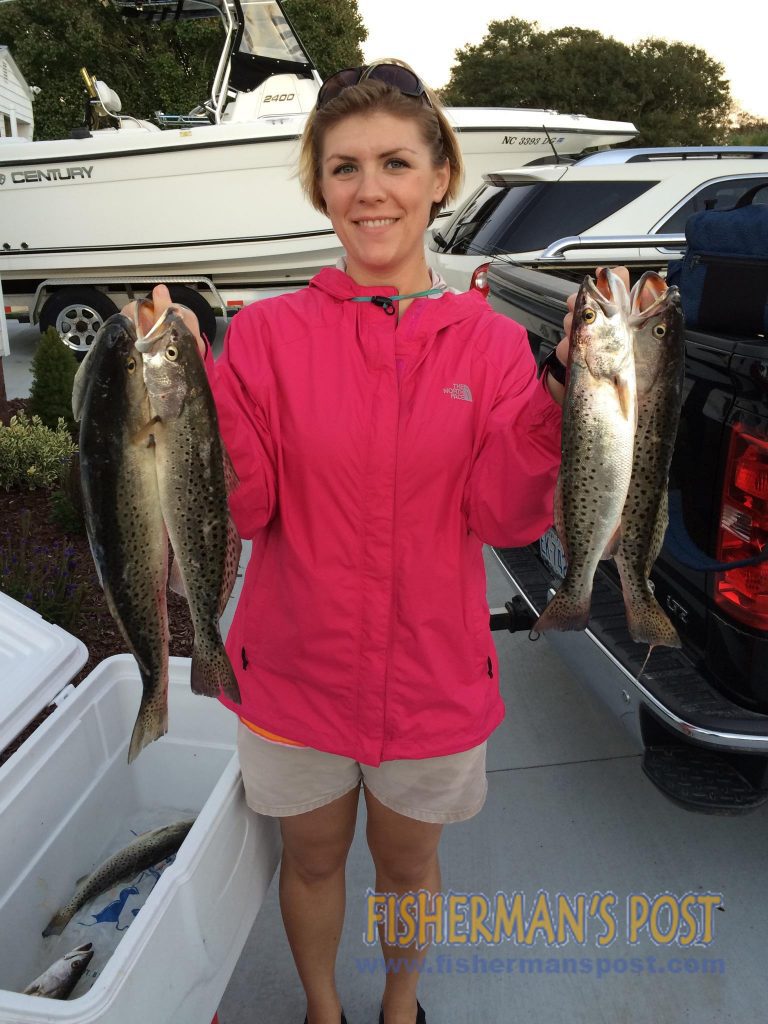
[{"left": 534, "top": 269, "right": 637, "bottom": 632}]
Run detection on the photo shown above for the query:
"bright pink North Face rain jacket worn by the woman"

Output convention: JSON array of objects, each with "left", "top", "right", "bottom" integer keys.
[{"left": 208, "top": 269, "right": 561, "bottom": 765}]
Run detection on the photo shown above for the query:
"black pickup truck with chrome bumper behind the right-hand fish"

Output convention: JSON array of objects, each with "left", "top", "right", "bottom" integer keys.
[{"left": 487, "top": 249, "right": 768, "bottom": 814}]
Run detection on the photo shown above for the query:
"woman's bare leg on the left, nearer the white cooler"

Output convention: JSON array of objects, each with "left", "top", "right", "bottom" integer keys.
[{"left": 280, "top": 786, "right": 359, "bottom": 1024}]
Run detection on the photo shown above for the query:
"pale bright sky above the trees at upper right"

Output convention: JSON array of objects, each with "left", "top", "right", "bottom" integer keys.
[{"left": 357, "top": 0, "right": 768, "bottom": 120}]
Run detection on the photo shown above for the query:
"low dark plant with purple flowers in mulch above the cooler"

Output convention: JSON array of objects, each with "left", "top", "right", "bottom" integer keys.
[{"left": 0, "top": 510, "right": 83, "bottom": 632}]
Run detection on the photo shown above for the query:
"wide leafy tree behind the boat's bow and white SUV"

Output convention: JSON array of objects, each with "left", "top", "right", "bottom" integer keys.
[{"left": 442, "top": 17, "right": 730, "bottom": 145}]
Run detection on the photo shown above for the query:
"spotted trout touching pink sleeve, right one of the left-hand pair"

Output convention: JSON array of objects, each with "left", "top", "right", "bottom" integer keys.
[{"left": 136, "top": 306, "right": 241, "bottom": 703}]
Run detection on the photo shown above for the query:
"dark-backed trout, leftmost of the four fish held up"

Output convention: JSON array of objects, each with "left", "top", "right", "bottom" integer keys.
[{"left": 72, "top": 313, "right": 168, "bottom": 762}]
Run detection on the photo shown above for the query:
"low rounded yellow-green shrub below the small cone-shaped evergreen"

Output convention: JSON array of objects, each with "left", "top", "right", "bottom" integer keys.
[{"left": 0, "top": 413, "right": 76, "bottom": 490}]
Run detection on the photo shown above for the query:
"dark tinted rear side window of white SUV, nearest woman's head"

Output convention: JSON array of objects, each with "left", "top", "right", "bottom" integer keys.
[{"left": 445, "top": 181, "right": 658, "bottom": 256}]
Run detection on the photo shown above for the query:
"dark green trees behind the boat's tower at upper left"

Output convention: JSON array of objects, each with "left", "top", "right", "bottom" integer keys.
[{"left": 0, "top": 0, "right": 368, "bottom": 139}]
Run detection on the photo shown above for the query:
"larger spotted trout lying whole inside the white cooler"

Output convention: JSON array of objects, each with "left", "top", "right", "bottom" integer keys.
[{"left": 43, "top": 818, "right": 195, "bottom": 938}]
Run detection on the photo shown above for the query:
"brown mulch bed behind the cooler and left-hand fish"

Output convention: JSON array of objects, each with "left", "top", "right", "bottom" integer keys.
[{"left": 0, "top": 399, "right": 194, "bottom": 764}]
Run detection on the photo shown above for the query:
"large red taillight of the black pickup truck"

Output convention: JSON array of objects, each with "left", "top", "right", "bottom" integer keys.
[{"left": 715, "top": 425, "right": 768, "bottom": 630}]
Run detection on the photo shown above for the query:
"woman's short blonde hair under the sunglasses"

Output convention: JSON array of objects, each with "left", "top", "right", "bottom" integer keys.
[{"left": 299, "top": 57, "right": 464, "bottom": 224}]
